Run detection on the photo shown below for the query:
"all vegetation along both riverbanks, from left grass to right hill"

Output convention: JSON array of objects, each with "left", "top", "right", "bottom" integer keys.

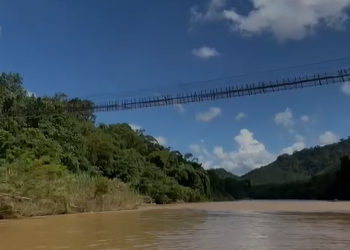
[{"left": 0, "top": 73, "right": 350, "bottom": 218}]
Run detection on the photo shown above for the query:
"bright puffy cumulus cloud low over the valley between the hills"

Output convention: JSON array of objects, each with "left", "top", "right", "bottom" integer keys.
[{"left": 190, "top": 129, "right": 276, "bottom": 174}]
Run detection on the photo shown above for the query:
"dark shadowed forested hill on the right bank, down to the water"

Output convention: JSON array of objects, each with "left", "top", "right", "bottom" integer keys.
[{"left": 243, "top": 137, "right": 350, "bottom": 200}]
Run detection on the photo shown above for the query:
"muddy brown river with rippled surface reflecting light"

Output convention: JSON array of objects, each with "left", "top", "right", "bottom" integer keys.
[{"left": 0, "top": 201, "right": 350, "bottom": 250}]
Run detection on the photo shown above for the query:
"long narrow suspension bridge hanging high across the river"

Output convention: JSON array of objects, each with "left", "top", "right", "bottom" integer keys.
[{"left": 83, "top": 69, "right": 350, "bottom": 112}]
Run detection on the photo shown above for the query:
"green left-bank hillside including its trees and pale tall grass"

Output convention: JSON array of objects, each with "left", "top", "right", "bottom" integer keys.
[{"left": 0, "top": 73, "right": 249, "bottom": 217}]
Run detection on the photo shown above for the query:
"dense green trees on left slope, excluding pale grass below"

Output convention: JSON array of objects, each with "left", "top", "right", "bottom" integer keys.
[{"left": 0, "top": 73, "right": 249, "bottom": 206}]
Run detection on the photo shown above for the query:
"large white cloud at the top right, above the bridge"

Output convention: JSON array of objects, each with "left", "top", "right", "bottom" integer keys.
[{"left": 190, "top": 0, "right": 350, "bottom": 41}]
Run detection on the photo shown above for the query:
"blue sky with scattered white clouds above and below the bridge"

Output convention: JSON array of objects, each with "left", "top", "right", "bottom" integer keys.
[{"left": 0, "top": 0, "right": 350, "bottom": 175}]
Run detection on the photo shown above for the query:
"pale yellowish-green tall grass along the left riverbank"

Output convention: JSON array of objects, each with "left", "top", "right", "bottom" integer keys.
[{"left": 0, "top": 160, "right": 142, "bottom": 219}]
